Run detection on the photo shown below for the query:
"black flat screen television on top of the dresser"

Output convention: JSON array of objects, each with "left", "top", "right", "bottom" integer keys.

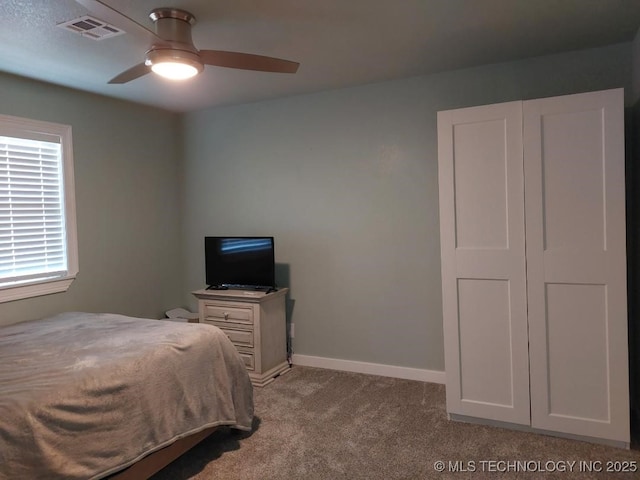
[{"left": 204, "top": 237, "right": 276, "bottom": 291}]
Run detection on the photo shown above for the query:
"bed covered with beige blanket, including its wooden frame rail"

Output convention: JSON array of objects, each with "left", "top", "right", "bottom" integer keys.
[{"left": 0, "top": 313, "right": 253, "bottom": 480}]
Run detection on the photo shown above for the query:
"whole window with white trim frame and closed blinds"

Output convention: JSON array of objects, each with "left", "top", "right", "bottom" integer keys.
[{"left": 0, "top": 115, "right": 78, "bottom": 302}]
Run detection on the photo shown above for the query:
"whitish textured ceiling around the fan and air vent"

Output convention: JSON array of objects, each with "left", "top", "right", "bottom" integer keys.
[{"left": 0, "top": 0, "right": 640, "bottom": 112}]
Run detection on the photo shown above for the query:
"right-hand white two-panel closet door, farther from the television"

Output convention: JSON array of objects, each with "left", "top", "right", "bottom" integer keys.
[{"left": 523, "top": 89, "right": 629, "bottom": 442}]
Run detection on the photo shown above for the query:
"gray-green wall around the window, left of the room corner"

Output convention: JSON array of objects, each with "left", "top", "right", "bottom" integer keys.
[{"left": 0, "top": 74, "right": 183, "bottom": 324}]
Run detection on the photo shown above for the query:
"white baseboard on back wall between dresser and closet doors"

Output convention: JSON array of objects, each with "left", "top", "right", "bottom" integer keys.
[{"left": 292, "top": 353, "right": 445, "bottom": 384}]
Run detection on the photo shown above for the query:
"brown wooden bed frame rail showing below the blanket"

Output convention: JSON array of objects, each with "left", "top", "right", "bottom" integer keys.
[{"left": 107, "top": 427, "right": 218, "bottom": 480}]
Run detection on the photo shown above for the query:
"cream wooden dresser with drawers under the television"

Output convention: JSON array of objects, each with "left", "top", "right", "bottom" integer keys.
[{"left": 193, "top": 288, "right": 289, "bottom": 387}]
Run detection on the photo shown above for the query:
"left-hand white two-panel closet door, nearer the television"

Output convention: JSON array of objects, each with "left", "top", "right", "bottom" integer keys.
[{"left": 438, "top": 102, "right": 530, "bottom": 425}]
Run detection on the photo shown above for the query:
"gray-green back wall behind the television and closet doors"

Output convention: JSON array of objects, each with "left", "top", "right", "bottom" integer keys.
[{"left": 182, "top": 43, "right": 632, "bottom": 370}]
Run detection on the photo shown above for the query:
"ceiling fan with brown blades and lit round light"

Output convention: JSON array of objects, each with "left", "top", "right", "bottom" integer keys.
[{"left": 76, "top": 0, "right": 300, "bottom": 83}]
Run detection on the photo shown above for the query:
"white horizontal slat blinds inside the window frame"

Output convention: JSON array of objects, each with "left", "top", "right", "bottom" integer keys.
[{"left": 0, "top": 136, "right": 67, "bottom": 286}]
